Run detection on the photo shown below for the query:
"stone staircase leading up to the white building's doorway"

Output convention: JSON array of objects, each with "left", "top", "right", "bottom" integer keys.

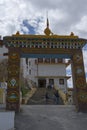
[{"left": 27, "top": 88, "right": 63, "bottom": 105}]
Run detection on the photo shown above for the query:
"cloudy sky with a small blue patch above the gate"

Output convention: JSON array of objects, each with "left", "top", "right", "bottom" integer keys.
[{"left": 0, "top": 0, "right": 87, "bottom": 87}]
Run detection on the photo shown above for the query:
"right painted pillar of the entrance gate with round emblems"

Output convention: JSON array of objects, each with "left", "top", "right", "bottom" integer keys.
[{"left": 72, "top": 50, "right": 87, "bottom": 112}]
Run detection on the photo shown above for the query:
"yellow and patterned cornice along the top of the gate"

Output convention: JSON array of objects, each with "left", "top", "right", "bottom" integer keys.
[{"left": 3, "top": 36, "right": 87, "bottom": 49}]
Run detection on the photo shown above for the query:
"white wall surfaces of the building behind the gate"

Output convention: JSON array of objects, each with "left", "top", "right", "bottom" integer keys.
[{"left": 24, "top": 58, "right": 67, "bottom": 91}]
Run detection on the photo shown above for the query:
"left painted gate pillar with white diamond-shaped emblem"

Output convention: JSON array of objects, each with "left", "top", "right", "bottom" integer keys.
[{"left": 6, "top": 48, "right": 20, "bottom": 112}]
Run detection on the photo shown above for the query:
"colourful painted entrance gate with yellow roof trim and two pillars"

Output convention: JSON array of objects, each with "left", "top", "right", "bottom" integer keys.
[{"left": 0, "top": 28, "right": 87, "bottom": 112}]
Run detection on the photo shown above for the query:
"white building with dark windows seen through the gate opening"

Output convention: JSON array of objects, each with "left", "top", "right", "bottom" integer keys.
[{"left": 22, "top": 58, "right": 70, "bottom": 93}]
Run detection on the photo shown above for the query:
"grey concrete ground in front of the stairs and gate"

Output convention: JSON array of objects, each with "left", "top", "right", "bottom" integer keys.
[{"left": 15, "top": 105, "right": 87, "bottom": 130}]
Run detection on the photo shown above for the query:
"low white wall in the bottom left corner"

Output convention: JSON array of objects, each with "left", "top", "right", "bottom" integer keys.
[{"left": 0, "top": 111, "right": 15, "bottom": 130}]
